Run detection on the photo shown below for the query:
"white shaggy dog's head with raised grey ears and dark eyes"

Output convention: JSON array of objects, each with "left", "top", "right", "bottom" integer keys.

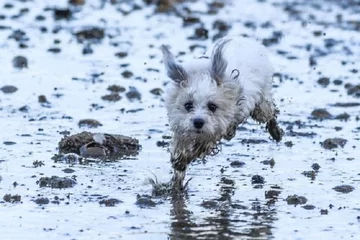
[{"left": 162, "top": 42, "right": 239, "bottom": 141}]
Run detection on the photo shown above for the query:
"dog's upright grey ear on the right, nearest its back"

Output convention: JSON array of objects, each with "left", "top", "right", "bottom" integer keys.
[{"left": 211, "top": 39, "right": 230, "bottom": 86}]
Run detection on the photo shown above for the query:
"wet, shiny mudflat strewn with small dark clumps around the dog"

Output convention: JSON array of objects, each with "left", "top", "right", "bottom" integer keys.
[{"left": 0, "top": 0, "right": 360, "bottom": 239}]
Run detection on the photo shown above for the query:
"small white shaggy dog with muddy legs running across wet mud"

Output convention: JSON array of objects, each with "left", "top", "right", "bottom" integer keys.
[{"left": 161, "top": 37, "right": 283, "bottom": 190}]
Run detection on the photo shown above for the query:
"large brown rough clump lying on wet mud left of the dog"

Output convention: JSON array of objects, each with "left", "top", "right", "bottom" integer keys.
[{"left": 59, "top": 132, "right": 141, "bottom": 158}]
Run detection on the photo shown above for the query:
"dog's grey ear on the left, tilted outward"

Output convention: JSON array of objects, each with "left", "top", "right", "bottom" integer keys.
[{"left": 161, "top": 45, "right": 188, "bottom": 84}]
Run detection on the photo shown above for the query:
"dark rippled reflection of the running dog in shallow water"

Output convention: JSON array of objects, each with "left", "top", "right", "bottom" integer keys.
[{"left": 169, "top": 177, "right": 276, "bottom": 239}]
